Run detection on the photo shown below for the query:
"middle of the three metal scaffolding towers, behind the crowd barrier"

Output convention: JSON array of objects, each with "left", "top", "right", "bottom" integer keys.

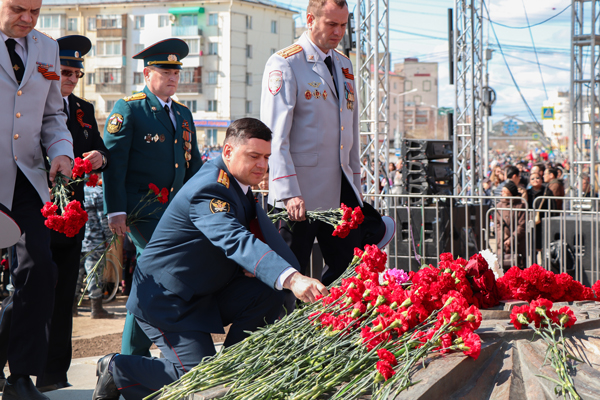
[{"left": 453, "top": 0, "right": 485, "bottom": 195}]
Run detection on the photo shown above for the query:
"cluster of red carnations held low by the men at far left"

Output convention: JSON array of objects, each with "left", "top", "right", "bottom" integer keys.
[{"left": 41, "top": 157, "right": 98, "bottom": 237}]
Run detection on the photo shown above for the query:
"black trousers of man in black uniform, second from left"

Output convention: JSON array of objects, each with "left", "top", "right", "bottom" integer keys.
[{"left": 36, "top": 236, "right": 82, "bottom": 386}]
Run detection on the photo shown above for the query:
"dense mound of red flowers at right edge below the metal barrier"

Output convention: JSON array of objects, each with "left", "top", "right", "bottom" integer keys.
[{"left": 496, "top": 264, "right": 600, "bottom": 302}]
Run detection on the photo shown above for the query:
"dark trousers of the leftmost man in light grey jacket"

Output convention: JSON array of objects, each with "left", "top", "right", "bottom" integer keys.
[{"left": 0, "top": 169, "right": 57, "bottom": 376}]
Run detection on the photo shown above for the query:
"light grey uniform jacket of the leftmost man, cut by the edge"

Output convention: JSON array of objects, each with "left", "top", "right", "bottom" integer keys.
[{"left": 0, "top": 30, "right": 73, "bottom": 209}]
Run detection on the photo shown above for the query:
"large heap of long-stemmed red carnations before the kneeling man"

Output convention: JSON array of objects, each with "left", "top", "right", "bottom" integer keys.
[{"left": 153, "top": 246, "right": 490, "bottom": 400}]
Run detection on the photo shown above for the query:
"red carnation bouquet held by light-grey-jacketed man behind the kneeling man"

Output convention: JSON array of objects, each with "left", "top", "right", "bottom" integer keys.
[{"left": 269, "top": 203, "right": 365, "bottom": 239}]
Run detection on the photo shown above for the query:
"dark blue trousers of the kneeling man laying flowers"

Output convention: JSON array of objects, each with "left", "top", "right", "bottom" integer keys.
[{"left": 113, "top": 274, "right": 283, "bottom": 400}]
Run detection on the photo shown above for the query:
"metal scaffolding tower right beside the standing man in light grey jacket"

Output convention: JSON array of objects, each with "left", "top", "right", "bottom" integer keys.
[{"left": 356, "top": 0, "right": 390, "bottom": 206}]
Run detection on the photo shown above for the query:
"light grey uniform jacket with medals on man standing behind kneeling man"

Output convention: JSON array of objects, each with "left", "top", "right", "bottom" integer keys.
[{"left": 260, "top": 33, "right": 360, "bottom": 210}]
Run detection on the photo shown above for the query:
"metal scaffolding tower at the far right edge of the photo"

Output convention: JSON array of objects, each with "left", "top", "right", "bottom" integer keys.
[{"left": 569, "top": 0, "right": 600, "bottom": 195}]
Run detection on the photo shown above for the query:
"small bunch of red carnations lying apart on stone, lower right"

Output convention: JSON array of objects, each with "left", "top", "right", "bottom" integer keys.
[{"left": 510, "top": 298, "right": 582, "bottom": 399}]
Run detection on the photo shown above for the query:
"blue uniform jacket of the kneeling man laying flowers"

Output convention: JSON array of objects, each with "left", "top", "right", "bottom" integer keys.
[{"left": 127, "top": 157, "right": 299, "bottom": 332}]
